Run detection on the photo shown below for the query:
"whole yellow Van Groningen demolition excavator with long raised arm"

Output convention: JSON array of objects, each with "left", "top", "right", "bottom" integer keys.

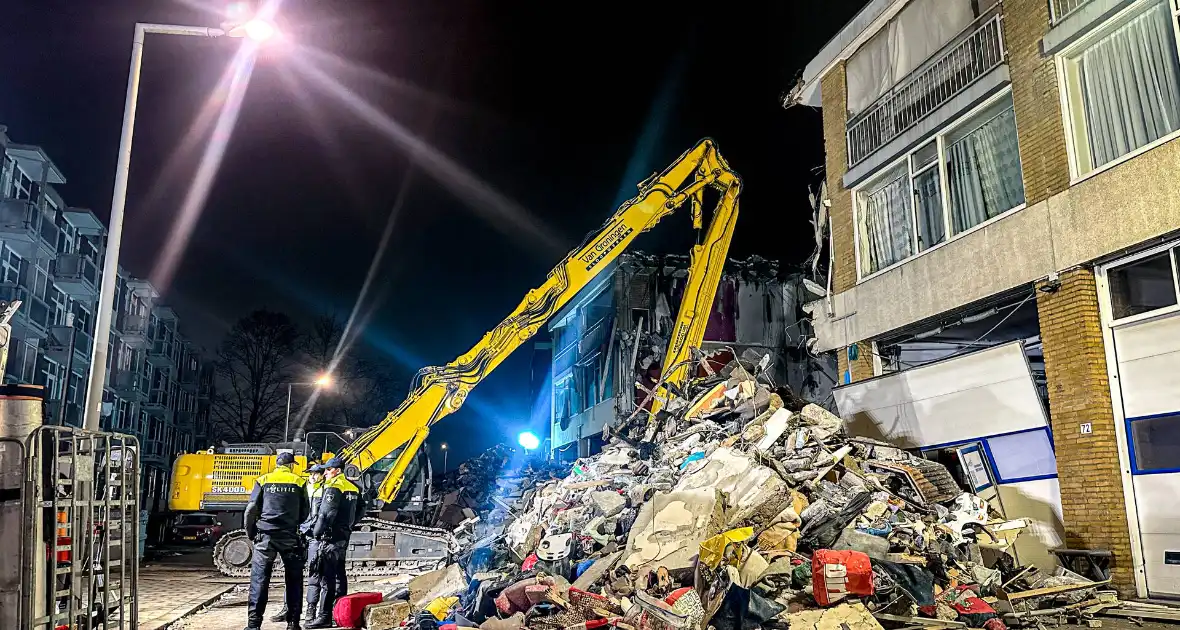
[{"left": 169, "top": 138, "right": 741, "bottom": 576}]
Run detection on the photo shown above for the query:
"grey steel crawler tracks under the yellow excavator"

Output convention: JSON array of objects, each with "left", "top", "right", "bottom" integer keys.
[{"left": 214, "top": 518, "right": 458, "bottom": 578}]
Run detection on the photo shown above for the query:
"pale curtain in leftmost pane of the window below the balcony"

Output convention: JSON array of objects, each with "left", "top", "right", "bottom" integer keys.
[{"left": 860, "top": 171, "right": 913, "bottom": 274}]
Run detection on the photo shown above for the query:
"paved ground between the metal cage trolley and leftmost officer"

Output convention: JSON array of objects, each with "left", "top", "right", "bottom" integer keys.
[{"left": 138, "top": 549, "right": 245, "bottom": 630}]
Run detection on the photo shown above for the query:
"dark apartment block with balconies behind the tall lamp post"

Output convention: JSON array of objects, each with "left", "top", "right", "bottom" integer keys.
[{"left": 0, "top": 126, "right": 212, "bottom": 519}]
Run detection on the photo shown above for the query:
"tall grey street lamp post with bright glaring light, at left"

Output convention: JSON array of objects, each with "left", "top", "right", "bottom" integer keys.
[{"left": 85, "top": 20, "right": 275, "bottom": 431}]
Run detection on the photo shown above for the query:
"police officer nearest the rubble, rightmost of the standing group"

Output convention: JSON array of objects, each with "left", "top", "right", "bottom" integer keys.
[{"left": 307, "top": 458, "right": 361, "bottom": 629}]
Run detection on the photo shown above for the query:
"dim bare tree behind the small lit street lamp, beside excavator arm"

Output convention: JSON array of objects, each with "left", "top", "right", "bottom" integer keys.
[{"left": 300, "top": 315, "right": 401, "bottom": 433}]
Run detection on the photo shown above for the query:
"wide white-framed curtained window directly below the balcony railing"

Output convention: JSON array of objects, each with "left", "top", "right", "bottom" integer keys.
[{"left": 856, "top": 92, "right": 1024, "bottom": 277}]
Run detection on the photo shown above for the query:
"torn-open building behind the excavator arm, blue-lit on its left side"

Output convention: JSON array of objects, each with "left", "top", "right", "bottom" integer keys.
[{"left": 544, "top": 254, "right": 835, "bottom": 459}]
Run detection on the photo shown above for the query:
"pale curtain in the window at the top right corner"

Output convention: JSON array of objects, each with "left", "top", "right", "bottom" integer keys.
[{"left": 1077, "top": 2, "right": 1180, "bottom": 166}]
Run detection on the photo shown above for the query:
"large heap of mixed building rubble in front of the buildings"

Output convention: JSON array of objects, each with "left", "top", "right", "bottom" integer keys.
[{"left": 375, "top": 354, "right": 1116, "bottom": 630}]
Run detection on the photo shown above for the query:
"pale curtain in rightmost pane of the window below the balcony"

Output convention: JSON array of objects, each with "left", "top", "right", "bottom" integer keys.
[{"left": 946, "top": 109, "right": 1024, "bottom": 234}]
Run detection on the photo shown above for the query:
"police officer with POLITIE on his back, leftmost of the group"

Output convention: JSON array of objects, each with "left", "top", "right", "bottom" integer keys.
[{"left": 244, "top": 453, "right": 310, "bottom": 630}]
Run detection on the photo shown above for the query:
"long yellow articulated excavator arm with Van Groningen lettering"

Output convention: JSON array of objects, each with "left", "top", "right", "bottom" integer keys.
[{"left": 341, "top": 139, "right": 741, "bottom": 503}]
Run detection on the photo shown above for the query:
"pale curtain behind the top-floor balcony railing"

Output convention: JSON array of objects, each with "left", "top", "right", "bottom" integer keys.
[{"left": 846, "top": 0, "right": 975, "bottom": 116}]
